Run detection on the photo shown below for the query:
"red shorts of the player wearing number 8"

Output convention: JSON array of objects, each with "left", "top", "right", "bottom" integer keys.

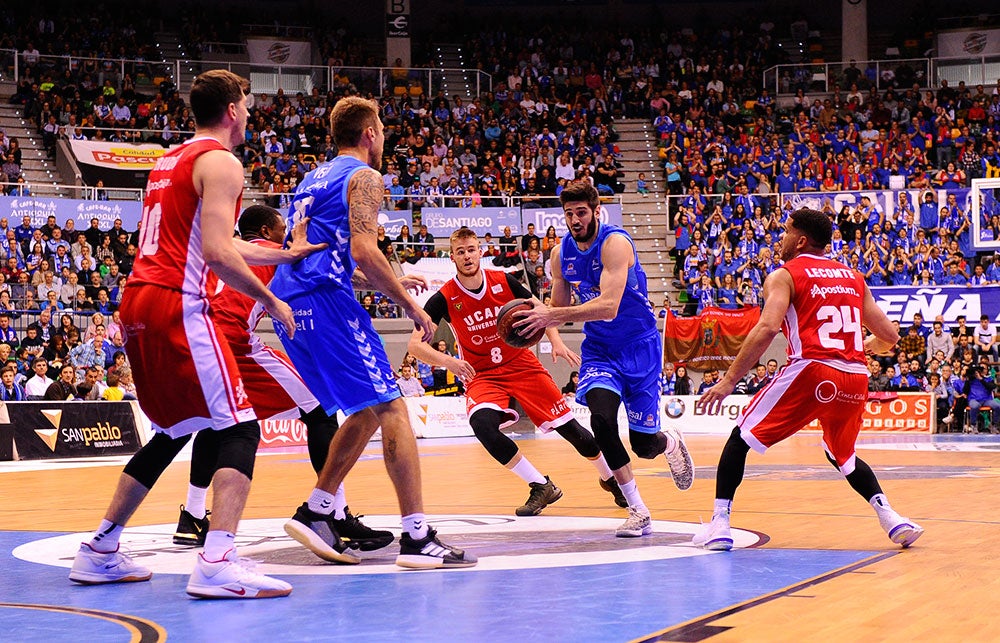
[{"left": 465, "top": 353, "right": 574, "bottom": 433}]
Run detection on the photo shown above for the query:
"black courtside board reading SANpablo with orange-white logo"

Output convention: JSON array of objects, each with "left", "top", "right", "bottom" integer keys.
[{"left": 10, "top": 401, "right": 141, "bottom": 460}]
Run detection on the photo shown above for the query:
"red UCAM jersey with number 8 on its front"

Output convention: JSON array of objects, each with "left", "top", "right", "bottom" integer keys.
[{"left": 439, "top": 270, "right": 538, "bottom": 373}]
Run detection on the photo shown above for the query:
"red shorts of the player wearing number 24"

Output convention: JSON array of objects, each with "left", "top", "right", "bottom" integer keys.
[{"left": 737, "top": 360, "right": 868, "bottom": 475}]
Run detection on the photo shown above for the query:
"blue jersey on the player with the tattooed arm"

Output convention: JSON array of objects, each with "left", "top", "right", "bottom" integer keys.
[{"left": 271, "top": 156, "right": 368, "bottom": 299}]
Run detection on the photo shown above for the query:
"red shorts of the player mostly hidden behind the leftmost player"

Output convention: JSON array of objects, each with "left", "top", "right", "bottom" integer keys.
[{"left": 232, "top": 335, "right": 319, "bottom": 420}]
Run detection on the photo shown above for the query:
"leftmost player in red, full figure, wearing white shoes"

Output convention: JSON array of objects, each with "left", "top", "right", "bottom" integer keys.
[{"left": 70, "top": 70, "right": 324, "bottom": 598}]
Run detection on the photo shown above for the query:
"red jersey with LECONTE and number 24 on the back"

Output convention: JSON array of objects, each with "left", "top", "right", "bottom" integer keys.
[{"left": 781, "top": 255, "right": 868, "bottom": 374}]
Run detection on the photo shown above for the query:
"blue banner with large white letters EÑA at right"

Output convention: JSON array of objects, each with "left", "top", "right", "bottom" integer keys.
[{"left": 871, "top": 285, "right": 1000, "bottom": 328}]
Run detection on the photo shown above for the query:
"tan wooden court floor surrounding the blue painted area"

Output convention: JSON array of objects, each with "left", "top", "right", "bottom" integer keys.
[{"left": 0, "top": 433, "right": 1000, "bottom": 641}]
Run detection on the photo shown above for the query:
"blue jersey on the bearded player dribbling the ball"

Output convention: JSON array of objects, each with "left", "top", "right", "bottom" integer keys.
[{"left": 559, "top": 223, "right": 656, "bottom": 344}]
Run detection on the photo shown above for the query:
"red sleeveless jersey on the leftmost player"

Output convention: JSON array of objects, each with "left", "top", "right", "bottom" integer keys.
[{"left": 129, "top": 137, "right": 240, "bottom": 298}]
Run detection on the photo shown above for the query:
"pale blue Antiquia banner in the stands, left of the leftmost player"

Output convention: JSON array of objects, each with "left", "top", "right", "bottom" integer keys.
[{"left": 0, "top": 196, "right": 142, "bottom": 231}]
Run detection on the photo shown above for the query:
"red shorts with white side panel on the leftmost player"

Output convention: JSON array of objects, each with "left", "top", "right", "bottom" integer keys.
[{"left": 121, "top": 285, "right": 256, "bottom": 437}]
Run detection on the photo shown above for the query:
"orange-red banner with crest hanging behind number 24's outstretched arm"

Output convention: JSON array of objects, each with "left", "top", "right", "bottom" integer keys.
[{"left": 663, "top": 306, "right": 760, "bottom": 371}]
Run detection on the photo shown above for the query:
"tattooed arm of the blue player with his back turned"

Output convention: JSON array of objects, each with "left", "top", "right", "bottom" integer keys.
[{"left": 347, "top": 169, "right": 435, "bottom": 341}]
